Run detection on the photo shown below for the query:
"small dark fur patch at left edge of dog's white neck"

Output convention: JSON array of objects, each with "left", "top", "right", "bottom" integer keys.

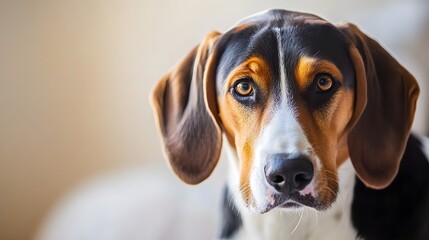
[{"left": 220, "top": 187, "right": 243, "bottom": 239}]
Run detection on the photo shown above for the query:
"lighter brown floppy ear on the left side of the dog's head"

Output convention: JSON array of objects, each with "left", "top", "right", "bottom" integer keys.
[{"left": 151, "top": 32, "right": 222, "bottom": 184}]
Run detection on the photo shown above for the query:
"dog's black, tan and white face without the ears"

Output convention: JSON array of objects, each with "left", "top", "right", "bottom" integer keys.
[{"left": 216, "top": 13, "right": 355, "bottom": 212}]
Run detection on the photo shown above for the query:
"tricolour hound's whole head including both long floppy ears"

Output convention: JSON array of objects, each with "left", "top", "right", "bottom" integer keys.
[{"left": 152, "top": 10, "right": 419, "bottom": 213}]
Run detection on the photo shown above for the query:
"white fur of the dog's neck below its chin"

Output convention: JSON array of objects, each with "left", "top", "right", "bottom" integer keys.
[{"left": 225, "top": 144, "right": 356, "bottom": 240}]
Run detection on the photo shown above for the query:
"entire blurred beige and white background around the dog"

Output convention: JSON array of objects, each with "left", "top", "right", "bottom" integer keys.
[{"left": 0, "top": 0, "right": 429, "bottom": 240}]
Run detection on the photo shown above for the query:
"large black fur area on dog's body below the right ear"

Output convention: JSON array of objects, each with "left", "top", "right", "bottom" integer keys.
[{"left": 352, "top": 135, "right": 429, "bottom": 240}]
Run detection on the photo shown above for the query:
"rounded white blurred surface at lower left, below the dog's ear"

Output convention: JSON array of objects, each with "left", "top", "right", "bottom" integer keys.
[{"left": 37, "top": 161, "right": 225, "bottom": 240}]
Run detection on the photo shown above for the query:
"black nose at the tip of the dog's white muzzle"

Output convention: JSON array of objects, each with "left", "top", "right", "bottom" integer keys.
[{"left": 264, "top": 153, "right": 314, "bottom": 193}]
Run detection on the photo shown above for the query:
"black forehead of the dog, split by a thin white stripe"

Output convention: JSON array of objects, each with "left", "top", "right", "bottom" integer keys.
[{"left": 216, "top": 10, "right": 353, "bottom": 87}]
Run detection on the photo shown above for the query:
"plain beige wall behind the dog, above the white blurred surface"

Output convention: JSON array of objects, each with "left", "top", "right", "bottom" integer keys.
[{"left": 0, "top": 0, "right": 427, "bottom": 240}]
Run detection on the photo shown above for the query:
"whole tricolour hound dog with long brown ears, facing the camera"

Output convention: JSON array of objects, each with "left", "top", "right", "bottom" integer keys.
[{"left": 152, "top": 10, "right": 429, "bottom": 240}]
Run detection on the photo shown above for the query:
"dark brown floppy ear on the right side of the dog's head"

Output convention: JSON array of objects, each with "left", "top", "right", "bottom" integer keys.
[{"left": 339, "top": 24, "right": 419, "bottom": 189}]
